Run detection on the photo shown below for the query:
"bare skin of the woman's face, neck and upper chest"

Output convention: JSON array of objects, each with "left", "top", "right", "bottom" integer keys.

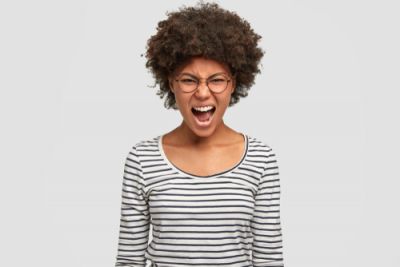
[{"left": 163, "top": 57, "right": 244, "bottom": 175}]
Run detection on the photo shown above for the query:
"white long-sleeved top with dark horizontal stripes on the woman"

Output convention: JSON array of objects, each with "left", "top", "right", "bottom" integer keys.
[{"left": 115, "top": 134, "right": 283, "bottom": 267}]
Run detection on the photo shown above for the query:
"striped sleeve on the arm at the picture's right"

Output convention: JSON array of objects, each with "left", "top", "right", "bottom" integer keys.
[{"left": 251, "top": 147, "right": 284, "bottom": 267}]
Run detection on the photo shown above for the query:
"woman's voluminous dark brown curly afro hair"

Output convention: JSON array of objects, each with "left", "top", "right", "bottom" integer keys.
[{"left": 146, "top": 1, "right": 264, "bottom": 109}]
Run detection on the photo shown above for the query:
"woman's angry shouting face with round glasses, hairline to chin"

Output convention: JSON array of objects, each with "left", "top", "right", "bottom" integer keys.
[{"left": 170, "top": 57, "right": 235, "bottom": 137}]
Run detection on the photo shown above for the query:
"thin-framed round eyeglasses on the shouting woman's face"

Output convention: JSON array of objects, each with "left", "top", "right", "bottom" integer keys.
[{"left": 175, "top": 73, "right": 231, "bottom": 94}]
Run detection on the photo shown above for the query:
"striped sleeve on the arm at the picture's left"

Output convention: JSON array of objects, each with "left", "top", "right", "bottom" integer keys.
[{"left": 115, "top": 146, "right": 150, "bottom": 267}]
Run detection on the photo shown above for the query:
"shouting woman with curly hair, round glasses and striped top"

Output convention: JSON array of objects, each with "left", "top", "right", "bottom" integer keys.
[{"left": 116, "top": 3, "right": 283, "bottom": 267}]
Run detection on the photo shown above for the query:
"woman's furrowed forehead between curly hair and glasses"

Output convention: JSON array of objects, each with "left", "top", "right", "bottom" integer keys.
[{"left": 174, "top": 57, "right": 229, "bottom": 77}]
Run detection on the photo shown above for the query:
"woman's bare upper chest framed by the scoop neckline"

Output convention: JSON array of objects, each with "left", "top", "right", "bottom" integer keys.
[{"left": 163, "top": 133, "right": 245, "bottom": 176}]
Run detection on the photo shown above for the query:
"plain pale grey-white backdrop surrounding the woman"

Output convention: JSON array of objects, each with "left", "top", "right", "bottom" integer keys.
[{"left": 0, "top": 0, "right": 400, "bottom": 267}]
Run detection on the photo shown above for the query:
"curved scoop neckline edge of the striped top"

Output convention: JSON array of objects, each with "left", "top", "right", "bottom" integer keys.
[{"left": 158, "top": 133, "right": 249, "bottom": 179}]
